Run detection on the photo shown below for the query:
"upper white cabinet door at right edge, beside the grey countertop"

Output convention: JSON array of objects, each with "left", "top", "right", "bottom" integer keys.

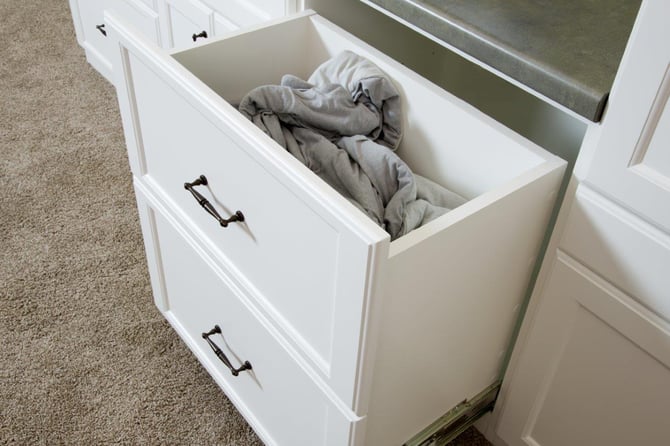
[{"left": 585, "top": 1, "right": 670, "bottom": 231}]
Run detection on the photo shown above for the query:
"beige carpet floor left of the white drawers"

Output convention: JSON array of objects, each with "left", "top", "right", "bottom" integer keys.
[{"left": 0, "top": 0, "right": 488, "bottom": 446}]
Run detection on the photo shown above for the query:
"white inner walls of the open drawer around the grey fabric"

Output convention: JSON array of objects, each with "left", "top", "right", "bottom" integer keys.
[{"left": 173, "top": 15, "right": 549, "bottom": 204}]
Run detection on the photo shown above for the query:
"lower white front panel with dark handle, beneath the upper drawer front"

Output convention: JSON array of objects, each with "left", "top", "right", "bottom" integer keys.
[{"left": 137, "top": 184, "right": 356, "bottom": 446}]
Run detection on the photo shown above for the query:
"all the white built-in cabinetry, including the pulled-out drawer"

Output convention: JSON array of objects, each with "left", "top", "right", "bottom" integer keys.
[{"left": 70, "top": 0, "right": 670, "bottom": 446}]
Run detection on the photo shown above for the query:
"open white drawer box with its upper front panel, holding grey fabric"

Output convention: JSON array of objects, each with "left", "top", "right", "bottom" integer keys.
[{"left": 106, "top": 12, "right": 565, "bottom": 445}]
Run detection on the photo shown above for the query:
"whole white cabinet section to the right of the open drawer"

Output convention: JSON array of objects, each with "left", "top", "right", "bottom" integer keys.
[{"left": 490, "top": 0, "right": 670, "bottom": 446}]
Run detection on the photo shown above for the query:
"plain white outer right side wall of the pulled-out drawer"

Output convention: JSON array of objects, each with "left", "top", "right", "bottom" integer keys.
[{"left": 366, "top": 164, "right": 564, "bottom": 444}]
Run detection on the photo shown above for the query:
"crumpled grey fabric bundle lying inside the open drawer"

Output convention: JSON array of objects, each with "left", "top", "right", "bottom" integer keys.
[{"left": 239, "top": 51, "right": 466, "bottom": 240}]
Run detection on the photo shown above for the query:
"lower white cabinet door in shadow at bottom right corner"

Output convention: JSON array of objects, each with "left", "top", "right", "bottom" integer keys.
[{"left": 497, "top": 252, "right": 670, "bottom": 446}]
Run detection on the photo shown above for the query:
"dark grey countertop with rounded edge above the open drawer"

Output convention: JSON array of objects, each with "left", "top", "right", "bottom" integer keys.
[{"left": 369, "top": 0, "right": 640, "bottom": 122}]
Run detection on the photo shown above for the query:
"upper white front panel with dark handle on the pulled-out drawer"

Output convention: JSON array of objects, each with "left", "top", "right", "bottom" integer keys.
[{"left": 108, "top": 13, "right": 388, "bottom": 407}]
